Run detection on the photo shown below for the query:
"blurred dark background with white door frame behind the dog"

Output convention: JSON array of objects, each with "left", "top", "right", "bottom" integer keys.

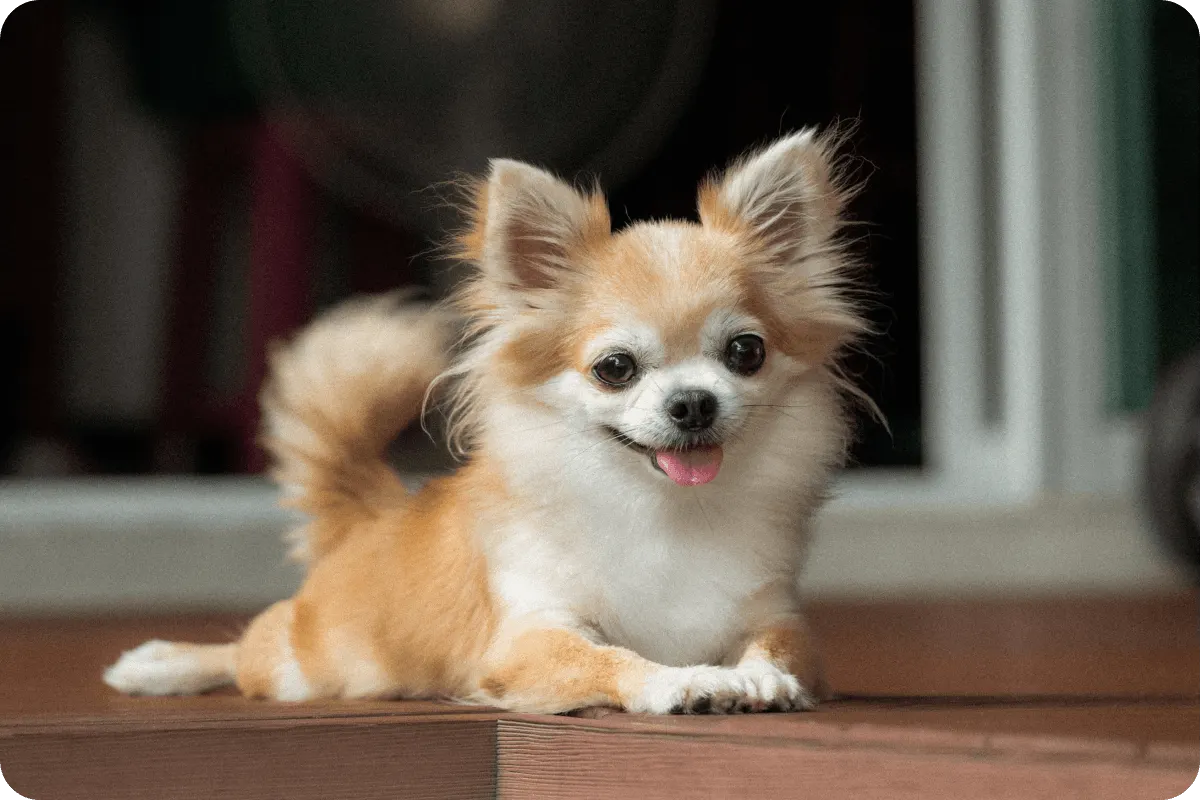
[{"left": 0, "top": 0, "right": 1199, "bottom": 610}]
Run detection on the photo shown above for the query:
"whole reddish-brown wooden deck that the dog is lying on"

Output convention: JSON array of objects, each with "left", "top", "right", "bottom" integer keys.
[{"left": 0, "top": 592, "right": 1201, "bottom": 800}]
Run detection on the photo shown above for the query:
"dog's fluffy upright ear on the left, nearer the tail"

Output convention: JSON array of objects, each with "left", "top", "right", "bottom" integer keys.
[{"left": 459, "top": 159, "right": 610, "bottom": 305}]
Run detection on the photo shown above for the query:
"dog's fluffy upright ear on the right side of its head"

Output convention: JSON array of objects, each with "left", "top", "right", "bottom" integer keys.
[{"left": 698, "top": 129, "right": 849, "bottom": 267}]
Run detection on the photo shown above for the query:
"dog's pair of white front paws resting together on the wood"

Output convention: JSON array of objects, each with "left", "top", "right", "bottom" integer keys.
[{"left": 627, "top": 664, "right": 815, "bottom": 714}]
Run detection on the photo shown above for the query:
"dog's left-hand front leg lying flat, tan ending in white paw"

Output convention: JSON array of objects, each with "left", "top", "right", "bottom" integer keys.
[{"left": 473, "top": 628, "right": 799, "bottom": 714}]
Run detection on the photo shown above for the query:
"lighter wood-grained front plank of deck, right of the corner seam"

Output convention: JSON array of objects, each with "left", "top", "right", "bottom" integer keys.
[{"left": 497, "top": 720, "right": 1196, "bottom": 800}]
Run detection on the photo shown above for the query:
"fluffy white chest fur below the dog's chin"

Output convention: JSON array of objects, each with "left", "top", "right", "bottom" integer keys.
[{"left": 477, "top": 468, "right": 801, "bottom": 665}]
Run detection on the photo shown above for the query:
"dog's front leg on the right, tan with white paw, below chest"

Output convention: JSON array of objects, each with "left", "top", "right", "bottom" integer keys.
[{"left": 736, "top": 614, "right": 830, "bottom": 711}]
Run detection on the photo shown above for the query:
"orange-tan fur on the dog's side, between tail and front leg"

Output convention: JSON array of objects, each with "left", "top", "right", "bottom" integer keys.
[{"left": 283, "top": 465, "right": 503, "bottom": 697}]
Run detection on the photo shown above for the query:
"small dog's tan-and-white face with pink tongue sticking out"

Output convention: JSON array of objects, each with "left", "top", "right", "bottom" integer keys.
[{"left": 557, "top": 223, "right": 803, "bottom": 485}]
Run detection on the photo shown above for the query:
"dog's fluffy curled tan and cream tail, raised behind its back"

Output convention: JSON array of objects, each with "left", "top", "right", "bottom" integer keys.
[{"left": 261, "top": 294, "right": 450, "bottom": 561}]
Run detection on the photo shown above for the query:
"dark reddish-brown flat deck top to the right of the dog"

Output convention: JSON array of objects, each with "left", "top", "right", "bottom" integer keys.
[{"left": 811, "top": 590, "right": 1201, "bottom": 697}]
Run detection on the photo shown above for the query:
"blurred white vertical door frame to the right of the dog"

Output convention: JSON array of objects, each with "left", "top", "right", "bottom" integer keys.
[{"left": 837, "top": 0, "right": 1140, "bottom": 508}]
